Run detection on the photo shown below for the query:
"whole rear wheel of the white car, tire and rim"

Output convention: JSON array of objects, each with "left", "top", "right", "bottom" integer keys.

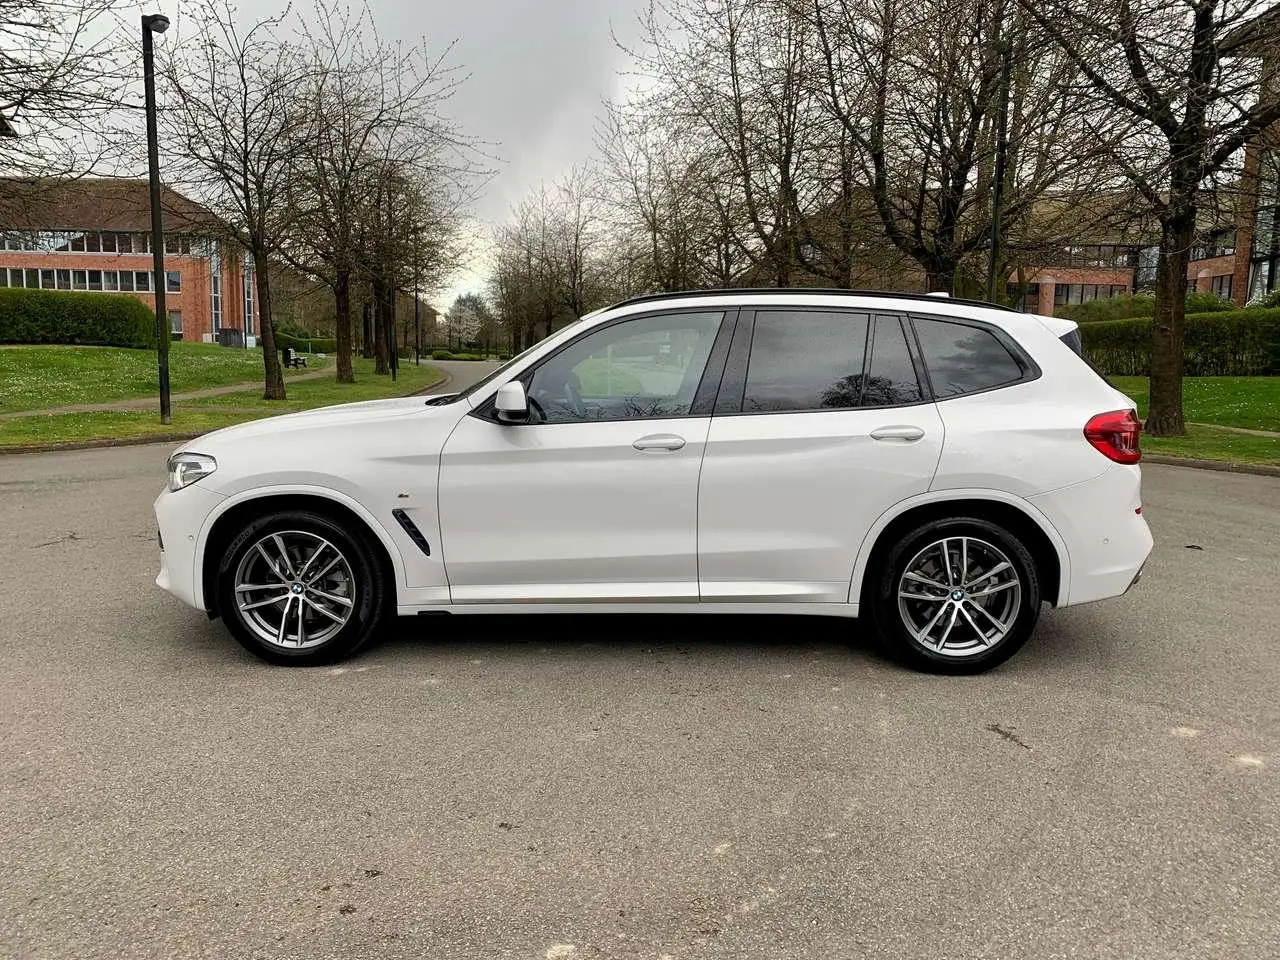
[{"left": 872, "top": 517, "right": 1041, "bottom": 673}]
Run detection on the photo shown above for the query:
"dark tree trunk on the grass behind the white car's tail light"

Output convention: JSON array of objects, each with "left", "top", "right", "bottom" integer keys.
[{"left": 1144, "top": 213, "right": 1196, "bottom": 436}]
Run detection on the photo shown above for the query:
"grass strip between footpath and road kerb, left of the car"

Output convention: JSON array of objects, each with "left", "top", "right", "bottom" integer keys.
[{"left": 0, "top": 358, "right": 443, "bottom": 447}]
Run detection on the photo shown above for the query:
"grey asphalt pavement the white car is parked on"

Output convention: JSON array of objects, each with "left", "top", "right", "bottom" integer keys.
[{"left": 0, "top": 447, "right": 1280, "bottom": 960}]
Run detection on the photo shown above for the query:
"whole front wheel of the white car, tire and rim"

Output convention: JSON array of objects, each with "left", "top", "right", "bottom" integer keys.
[{"left": 218, "top": 511, "right": 385, "bottom": 667}]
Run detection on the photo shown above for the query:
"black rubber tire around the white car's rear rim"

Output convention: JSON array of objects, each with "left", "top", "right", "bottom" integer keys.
[{"left": 870, "top": 517, "right": 1041, "bottom": 673}]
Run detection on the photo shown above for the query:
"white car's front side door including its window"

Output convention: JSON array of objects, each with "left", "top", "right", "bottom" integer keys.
[{"left": 439, "top": 311, "right": 732, "bottom": 603}]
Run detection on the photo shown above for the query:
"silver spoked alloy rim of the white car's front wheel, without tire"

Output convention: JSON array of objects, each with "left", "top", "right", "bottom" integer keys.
[{"left": 236, "top": 530, "right": 356, "bottom": 650}]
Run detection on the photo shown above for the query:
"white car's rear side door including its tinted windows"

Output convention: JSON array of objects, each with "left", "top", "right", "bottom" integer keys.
[{"left": 698, "top": 307, "right": 943, "bottom": 603}]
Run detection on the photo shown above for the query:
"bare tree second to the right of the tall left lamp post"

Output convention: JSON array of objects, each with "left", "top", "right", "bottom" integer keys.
[{"left": 285, "top": 3, "right": 479, "bottom": 383}]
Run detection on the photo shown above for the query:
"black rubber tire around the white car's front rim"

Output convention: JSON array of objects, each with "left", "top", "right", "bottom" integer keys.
[{"left": 218, "top": 511, "right": 390, "bottom": 667}]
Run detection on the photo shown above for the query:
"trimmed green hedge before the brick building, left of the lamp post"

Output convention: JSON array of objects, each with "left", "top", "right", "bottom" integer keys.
[{"left": 0, "top": 287, "right": 156, "bottom": 349}]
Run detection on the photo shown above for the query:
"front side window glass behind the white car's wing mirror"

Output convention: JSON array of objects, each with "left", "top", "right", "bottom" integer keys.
[{"left": 527, "top": 312, "right": 724, "bottom": 424}]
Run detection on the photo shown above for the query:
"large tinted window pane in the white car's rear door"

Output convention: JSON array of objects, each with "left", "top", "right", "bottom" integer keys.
[{"left": 742, "top": 310, "right": 868, "bottom": 412}]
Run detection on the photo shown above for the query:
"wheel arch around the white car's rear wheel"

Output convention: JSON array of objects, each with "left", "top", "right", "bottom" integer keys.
[{"left": 849, "top": 490, "right": 1071, "bottom": 611}]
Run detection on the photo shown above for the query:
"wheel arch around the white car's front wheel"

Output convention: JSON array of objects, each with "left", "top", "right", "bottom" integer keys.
[{"left": 193, "top": 486, "right": 404, "bottom": 617}]
